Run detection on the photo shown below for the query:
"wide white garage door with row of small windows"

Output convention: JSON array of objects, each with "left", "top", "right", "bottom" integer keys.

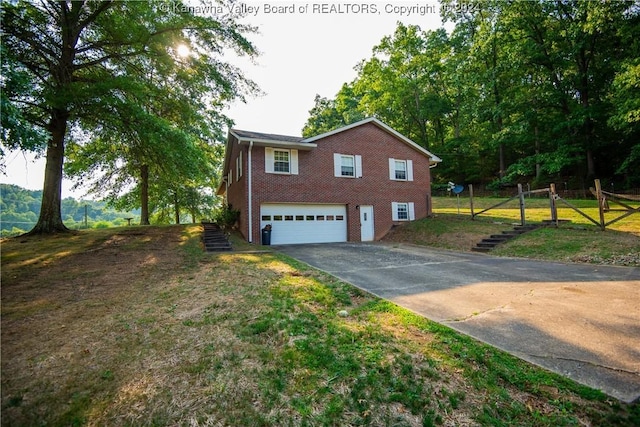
[{"left": 260, "top": 204, "right": 347, "bottom": 245}]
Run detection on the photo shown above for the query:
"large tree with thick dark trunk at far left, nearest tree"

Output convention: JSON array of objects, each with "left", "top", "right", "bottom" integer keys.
[{"left": 2, "top": 0, "right": 256, "bottom": 233}]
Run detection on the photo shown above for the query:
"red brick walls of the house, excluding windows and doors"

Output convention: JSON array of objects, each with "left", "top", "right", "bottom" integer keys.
[{"left": 242, "top": 123, "right": 431, "bottom": 242}]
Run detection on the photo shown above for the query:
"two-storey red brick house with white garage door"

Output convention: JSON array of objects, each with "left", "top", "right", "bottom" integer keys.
[{"left": 217, "top": 118, "right": 441, "bottom": 244}]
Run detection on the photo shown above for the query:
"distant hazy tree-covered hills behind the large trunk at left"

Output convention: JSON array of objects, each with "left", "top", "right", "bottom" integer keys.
[{"left": 0, "top": 184, "right": 140, "bottom": 237}]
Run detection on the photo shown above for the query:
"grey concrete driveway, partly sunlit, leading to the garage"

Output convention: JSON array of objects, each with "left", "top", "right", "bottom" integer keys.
[{"left": 275, "top": 243, "right": 640, "bottom": 402}]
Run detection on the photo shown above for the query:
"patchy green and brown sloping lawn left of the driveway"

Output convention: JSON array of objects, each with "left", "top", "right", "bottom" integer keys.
[{"left": 1, "top": 226, "right": 640, "bottom": 426}]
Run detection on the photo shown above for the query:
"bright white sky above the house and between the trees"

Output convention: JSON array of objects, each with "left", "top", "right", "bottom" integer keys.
[{"left": 0, "top": 0, "right": 442, "bottom": 198}]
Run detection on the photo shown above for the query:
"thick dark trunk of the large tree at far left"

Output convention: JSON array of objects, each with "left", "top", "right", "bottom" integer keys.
[{"left": 28, "top": 110, "right": 69, "bottom": 234}]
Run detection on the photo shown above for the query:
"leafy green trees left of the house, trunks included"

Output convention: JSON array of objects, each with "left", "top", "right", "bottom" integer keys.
[{"left": 1, "top": 1, "right": 257, "bottom": 232}]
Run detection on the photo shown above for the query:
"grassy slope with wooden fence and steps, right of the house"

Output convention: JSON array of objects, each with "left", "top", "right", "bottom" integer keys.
[{"left": 385, "top": 197, "right": 640, "bottom": 266}]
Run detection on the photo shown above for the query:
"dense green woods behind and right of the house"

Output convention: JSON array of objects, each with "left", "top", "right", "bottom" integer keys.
[{"left": 303, "top": 0, "right": 640, "bottom": 188}]
